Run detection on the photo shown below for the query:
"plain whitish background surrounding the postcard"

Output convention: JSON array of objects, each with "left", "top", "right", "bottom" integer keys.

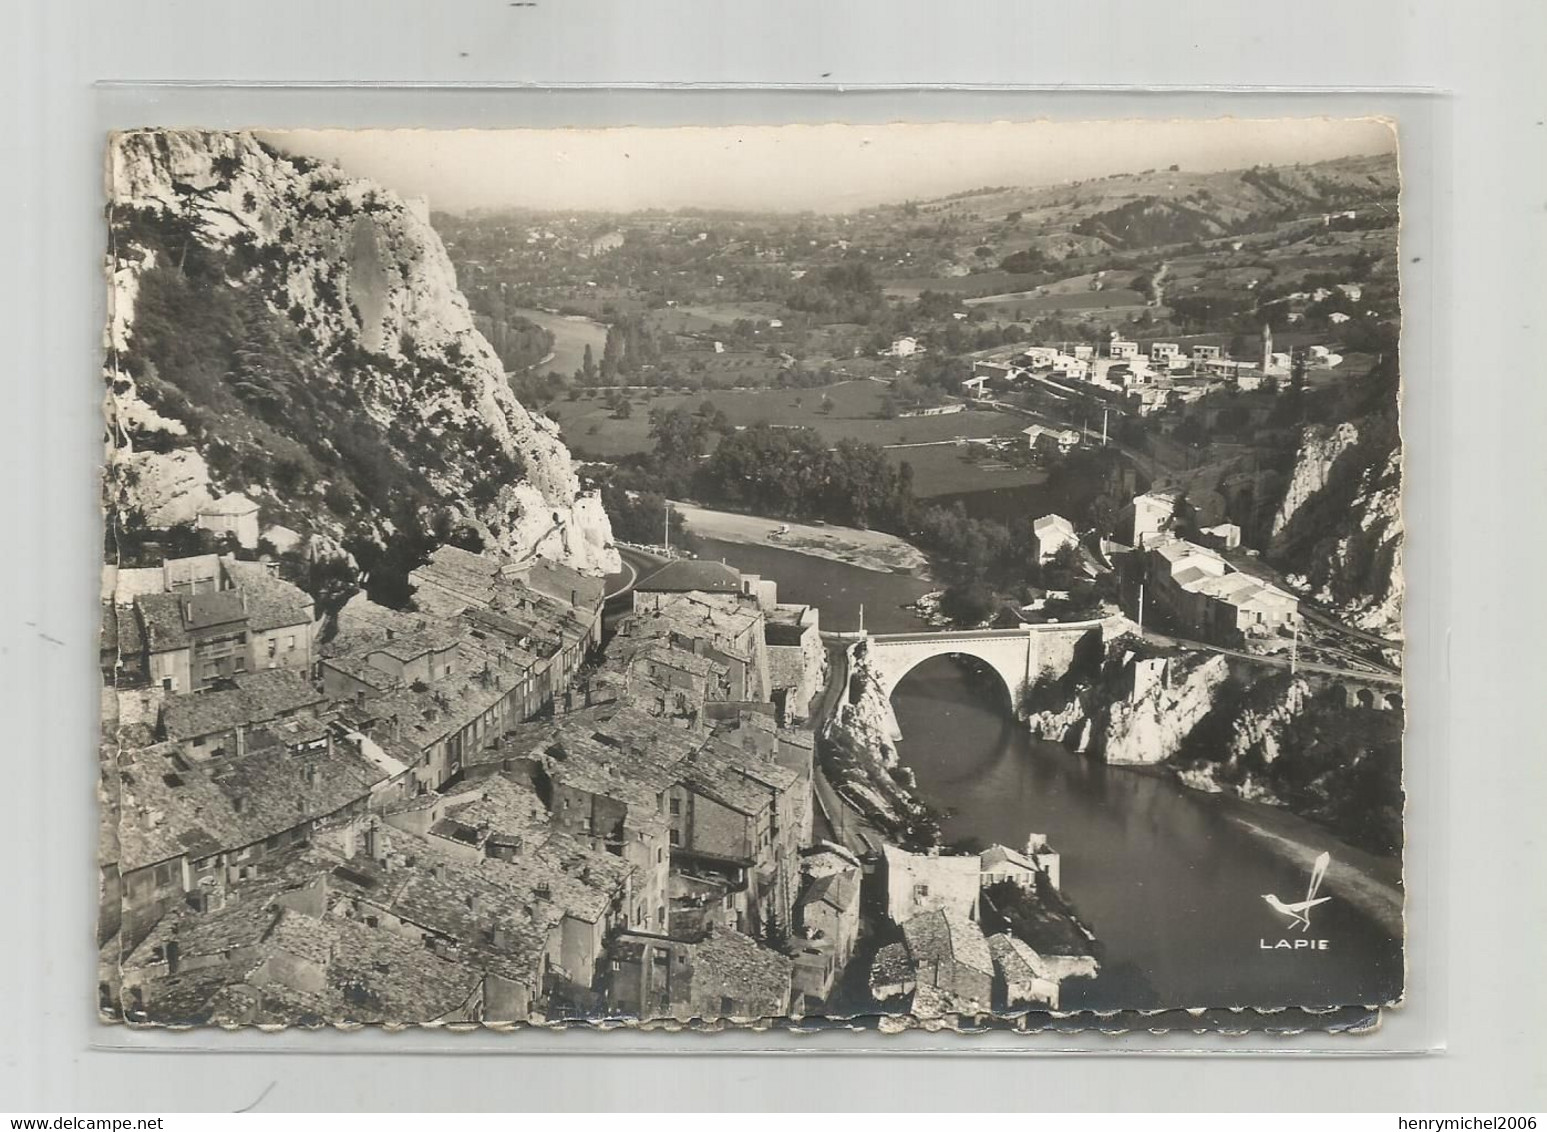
[{"left": 0, "top": 0, "right": 1547, "bottom": 1112}]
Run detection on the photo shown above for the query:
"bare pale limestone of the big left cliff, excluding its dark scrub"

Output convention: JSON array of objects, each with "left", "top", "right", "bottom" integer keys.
[{"left": 105, "top": 130, "right": 619, "bottom": 571}]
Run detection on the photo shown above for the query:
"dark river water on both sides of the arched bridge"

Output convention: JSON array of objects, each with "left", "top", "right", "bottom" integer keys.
[{"left": 699, "top": 540, "right": 1402, "bottom": 1010}]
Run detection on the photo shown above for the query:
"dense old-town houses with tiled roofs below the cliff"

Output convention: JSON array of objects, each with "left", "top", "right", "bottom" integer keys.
[{"left": 101, "top": 535, "right": 857, "bottom": 1022}]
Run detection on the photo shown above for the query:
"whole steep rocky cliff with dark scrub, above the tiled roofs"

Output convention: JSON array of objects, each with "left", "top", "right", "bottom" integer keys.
[{"left": 105, "top": 130, "right": 617, "bottom": 571}]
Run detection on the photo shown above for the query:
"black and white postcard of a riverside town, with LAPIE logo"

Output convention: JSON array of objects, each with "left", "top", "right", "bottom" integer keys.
[{"left": 93, "top": 119, "right": 1405, "bottom": 1042}]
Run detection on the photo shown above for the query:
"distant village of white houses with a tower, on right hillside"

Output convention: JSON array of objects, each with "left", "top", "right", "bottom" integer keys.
[{"left": 962, "top": 326, "right": 1343, "bottom": 414}]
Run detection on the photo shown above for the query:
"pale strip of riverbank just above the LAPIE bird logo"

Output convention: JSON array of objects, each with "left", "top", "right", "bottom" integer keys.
[{"left": 1204, "top": 782, "right": 1405, "bottom": 939}]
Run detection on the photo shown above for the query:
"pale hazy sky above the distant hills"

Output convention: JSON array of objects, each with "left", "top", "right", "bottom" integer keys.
[{"left": 261, "top": 118, "right": 1395, "bottom": 212}]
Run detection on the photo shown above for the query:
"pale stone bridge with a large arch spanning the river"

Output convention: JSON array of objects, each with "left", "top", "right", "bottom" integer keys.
[{"left": 863, "top": 619, "right": 1122, "bottom": 711}]
